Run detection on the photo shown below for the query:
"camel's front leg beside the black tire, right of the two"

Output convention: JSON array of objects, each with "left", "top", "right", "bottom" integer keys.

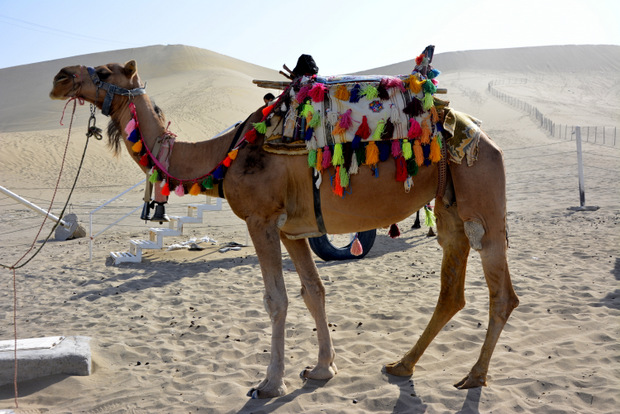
[{"left": 282, "top": 236, "right": 338, "bottom": 380}]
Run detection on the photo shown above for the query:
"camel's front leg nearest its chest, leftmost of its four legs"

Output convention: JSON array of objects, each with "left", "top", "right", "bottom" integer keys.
[{"left": 246, "top": 218, "right": 288, "bottom": 398}]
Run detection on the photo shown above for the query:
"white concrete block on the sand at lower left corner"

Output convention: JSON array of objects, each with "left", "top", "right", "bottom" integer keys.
[{"left": 0, "top": 336, "right": 92, "bottom": 386}]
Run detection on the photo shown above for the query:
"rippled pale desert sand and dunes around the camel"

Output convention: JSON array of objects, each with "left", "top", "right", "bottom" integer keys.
[{"left": 0, "top": 45, "right": 620, "bottom": 413}]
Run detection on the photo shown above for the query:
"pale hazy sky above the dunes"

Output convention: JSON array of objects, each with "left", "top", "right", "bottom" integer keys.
[{"left": 0, "top": 0, "right": 620, "bottom": 75}]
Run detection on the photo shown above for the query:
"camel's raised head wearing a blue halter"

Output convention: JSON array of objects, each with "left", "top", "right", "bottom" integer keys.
[{"left": 50, "top": 60, "right": 144, "bottom": 113}]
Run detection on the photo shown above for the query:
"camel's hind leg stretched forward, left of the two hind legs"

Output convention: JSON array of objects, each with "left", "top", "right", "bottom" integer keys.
[{"left": 385, "top": 204, "right": 469, "bottom": 376}]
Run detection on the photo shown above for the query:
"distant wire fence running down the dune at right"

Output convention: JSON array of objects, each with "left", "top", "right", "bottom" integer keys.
[{"left": 488, "top": 78, "right": 618, "bottom": 147}]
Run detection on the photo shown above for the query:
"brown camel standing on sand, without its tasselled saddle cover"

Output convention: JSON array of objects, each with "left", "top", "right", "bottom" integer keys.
[{"left": 50, "top": 61, "right": 518, "bottom": 398}]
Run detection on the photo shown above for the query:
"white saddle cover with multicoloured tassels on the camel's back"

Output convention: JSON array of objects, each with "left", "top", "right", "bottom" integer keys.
[{"left": 255, "top": 54, "right": 458, "bottom": 196}]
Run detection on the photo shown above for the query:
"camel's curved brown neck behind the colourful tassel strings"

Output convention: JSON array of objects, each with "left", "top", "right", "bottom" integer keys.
[{"left": 112, "top": 94, "right": 233, "bottom": 196}]
